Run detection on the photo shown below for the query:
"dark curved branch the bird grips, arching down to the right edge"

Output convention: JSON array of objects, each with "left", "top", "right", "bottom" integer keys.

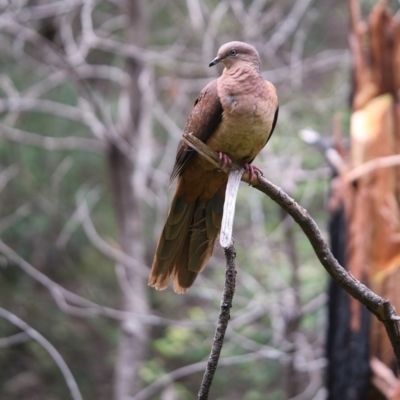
[{"left": 183, "top": 134, "right": 400, "bottom": 368}]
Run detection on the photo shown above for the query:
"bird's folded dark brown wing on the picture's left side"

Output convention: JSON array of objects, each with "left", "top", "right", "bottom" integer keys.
[{"left": 170, "top": 79, "right": 223, "bottom": 183}]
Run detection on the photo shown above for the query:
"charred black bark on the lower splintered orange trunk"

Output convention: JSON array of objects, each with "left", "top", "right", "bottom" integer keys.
[{"left": 326, "top": 203, "right": 371, "bottom": 400}]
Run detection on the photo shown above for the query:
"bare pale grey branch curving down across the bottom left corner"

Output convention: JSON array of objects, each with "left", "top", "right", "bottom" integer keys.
[{"left": 0, "top": 308, "right": 82, "bottom": 400}]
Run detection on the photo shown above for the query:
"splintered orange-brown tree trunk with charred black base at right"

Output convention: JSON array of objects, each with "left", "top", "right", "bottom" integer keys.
[{"left": 327, "top": 0, "right": 400, "bottom": 400}]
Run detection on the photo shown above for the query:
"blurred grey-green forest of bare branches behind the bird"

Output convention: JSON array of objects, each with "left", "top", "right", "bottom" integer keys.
[{"left": 0, "top": 0, "right": 388, "bottom": 400}]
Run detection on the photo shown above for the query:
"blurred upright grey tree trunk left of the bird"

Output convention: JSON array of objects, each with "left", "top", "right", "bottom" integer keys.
[{"left": 109, "top": 0, "right": 149, "bottom": 400}]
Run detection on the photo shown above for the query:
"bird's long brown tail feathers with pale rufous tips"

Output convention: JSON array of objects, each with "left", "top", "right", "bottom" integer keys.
[{"left": 148, "top": 183, "right": 225, "bottom": 293}]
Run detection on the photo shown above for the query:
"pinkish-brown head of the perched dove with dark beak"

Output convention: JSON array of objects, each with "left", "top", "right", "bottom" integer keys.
[{"left": 209, "top": 42, "right": 260, "bottom": 70}]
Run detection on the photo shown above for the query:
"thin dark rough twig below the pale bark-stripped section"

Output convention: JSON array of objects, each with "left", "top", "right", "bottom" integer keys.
[{"left": 198, "top": 244, "right": 236, "bottom": 400}]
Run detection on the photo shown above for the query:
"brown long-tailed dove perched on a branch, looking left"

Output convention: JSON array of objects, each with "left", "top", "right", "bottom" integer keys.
[{"left": 148, "top": 41, "right": 279, "bottom": 293}]
